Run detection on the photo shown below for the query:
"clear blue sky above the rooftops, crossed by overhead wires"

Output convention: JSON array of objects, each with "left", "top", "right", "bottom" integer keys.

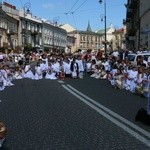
[{"left": 5, "top": 0, "right": 127, "bottom": 31}]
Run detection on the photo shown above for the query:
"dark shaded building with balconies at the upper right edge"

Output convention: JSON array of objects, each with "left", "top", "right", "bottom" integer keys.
[{"left": 125, "top": 0, "right": 150, "bottom": 49}]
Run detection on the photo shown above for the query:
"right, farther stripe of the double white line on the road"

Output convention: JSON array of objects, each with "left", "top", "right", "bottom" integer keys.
[{"left": 67, "top": 85, "right": 150, "bottom": 138}]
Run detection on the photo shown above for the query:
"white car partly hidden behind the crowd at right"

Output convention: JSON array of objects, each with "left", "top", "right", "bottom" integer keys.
[{"left": 128, "top": 52, "right": 150, "bottom": 65}]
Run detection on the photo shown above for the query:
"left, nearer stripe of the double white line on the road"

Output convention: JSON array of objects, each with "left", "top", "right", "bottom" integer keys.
[{"left": 62, "top": 85, "right": 150, "bottom": 147}]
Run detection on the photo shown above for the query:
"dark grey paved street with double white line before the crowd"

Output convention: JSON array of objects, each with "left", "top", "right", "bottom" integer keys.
[{"left": 0, "top": 77, "right": 150, "bottom": 150}]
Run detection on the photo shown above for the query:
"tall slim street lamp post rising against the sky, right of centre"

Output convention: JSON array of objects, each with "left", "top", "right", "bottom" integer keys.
[{"left": 99, "top": 0, "right": 107, "bottom": 58}]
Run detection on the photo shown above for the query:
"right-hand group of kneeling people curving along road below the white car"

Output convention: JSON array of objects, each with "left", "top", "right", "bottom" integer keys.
[{"left": 88, "top": 58, "right": 150, "bottom": 97}]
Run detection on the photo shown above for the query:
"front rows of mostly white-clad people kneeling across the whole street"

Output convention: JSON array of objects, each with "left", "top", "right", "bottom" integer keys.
[{"left": 0, "top": 50, "right": 150, "bottom": 97}]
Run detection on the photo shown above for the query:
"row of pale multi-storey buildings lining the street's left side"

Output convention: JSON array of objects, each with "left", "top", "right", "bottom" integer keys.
[{"left": 0, "top": 2, "right": 67, "bottom": 51}]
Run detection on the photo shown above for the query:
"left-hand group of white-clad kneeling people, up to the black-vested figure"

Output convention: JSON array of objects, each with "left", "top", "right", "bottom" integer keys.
[{"left": 0, "top": 52, "right": 84, "bottom": 90}]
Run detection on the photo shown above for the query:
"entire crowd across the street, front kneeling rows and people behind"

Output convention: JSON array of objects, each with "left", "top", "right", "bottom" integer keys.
[{"left": 0, "top": 50, "right": 150, "bottom": 101}]
